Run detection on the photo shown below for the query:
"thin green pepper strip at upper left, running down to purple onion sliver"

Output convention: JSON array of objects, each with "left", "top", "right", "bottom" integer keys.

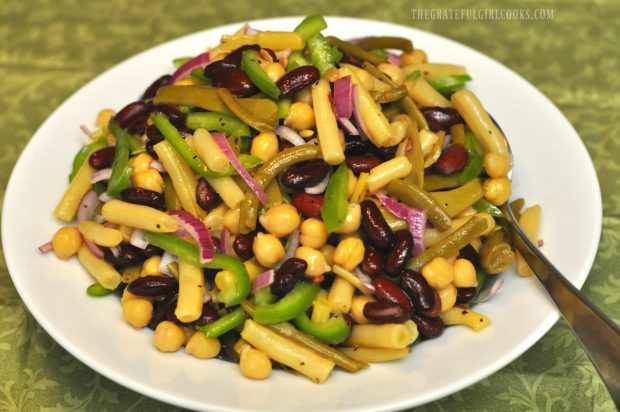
[{"left": 151, "top": 113, "right": 262, "bottom": 178}]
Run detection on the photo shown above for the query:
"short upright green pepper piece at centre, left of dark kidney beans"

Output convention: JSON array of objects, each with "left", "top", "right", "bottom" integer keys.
[{"left": 321, "top": 163, "right": 349, "bottom": 233}]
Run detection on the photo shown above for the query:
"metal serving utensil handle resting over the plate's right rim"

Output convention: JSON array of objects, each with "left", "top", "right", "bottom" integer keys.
[{"left": 501, "top": 205, "right": 620, "bottom": 405}]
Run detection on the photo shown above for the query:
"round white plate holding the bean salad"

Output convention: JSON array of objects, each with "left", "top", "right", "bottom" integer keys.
[{"left": 2, "top": 17, "right": 601, "bottom": 412}]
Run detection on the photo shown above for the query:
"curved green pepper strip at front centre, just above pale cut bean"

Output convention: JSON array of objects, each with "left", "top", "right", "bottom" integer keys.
[{"left": 253, "top": 282, "right": 321, "bottom": 325}]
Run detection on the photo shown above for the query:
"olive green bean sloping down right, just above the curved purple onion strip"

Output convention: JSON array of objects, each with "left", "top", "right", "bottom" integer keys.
[{"left": 388, "top": 179, "right": 452, "bottom": 232}]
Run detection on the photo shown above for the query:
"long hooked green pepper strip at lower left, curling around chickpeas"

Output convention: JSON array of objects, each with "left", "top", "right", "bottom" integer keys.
[{"left": 144, "top": 232, "right": 250, "bottom": 306}]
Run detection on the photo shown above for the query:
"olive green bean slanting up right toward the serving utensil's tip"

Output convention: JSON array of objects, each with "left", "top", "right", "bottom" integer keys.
[{"left": 407, "top": 215, "right": 487, "bottom": 271}]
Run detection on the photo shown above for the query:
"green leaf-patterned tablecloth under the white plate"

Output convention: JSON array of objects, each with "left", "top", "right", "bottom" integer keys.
[{"left": 0, "top": 0, "right": 620, "bottom": 411}]
